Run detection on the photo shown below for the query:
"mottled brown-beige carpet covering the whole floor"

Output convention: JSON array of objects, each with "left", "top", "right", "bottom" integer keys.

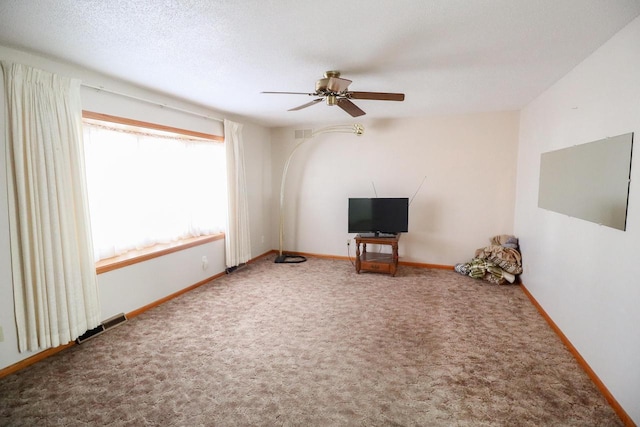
[{"left": 0, "top": 257, "right": 622, "bottom": 427}]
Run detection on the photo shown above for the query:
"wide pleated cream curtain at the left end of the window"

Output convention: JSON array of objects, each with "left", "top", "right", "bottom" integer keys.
[{"left": 2, "top": 62, "right": 100, "bottom": 352}]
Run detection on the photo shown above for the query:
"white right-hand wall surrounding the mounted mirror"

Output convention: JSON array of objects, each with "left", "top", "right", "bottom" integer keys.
[{"left": 515, "top": 18, "right": 640, "bottom": 424}]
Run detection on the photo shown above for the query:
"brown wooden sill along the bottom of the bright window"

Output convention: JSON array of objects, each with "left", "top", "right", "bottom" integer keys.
[{"left": 96, "top": 233, "right": 224, "bottom": 274}]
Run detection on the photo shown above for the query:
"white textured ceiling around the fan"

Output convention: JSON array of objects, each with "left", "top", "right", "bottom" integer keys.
[{"left": 0, "top": 0, "right": 640, "bottom": 126}]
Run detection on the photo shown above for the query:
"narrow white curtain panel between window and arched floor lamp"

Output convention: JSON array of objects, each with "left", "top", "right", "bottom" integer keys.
[{"left": 224, "top": 120, "right": 251, "bottom": 268}]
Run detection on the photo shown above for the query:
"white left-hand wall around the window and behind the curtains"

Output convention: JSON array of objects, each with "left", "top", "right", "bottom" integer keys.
[{"left": 0, "top": 46, "right": 272, "bottom": 369}]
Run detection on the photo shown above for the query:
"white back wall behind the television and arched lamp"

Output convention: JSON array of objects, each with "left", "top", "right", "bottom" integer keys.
[{"left": 272, "top": 111, "right": 519, "bottom": 266}]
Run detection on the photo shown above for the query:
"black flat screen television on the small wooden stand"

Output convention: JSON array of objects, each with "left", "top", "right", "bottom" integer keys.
[{"left": 348, "top": 197, "right": 409, "bottom": 237}]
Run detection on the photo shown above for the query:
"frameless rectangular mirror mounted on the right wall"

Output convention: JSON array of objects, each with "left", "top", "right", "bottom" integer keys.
[{"left": 538, "top": 133, "right": 633, "bottom": 231}]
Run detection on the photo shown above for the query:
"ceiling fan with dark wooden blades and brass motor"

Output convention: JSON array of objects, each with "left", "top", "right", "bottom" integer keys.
[{"left": 262, "top": 71, "right": 404, "bottom": 117}]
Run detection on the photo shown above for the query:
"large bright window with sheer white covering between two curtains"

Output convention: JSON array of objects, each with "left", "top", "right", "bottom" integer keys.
[{"left": 83, "top": 113, "right": 226, "bottom": 261}]
